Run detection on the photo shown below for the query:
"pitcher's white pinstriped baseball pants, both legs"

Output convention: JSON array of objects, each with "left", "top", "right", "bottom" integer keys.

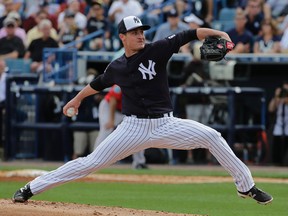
[{"left": 30, "top": 116, "right": 254, "bottom": 194}]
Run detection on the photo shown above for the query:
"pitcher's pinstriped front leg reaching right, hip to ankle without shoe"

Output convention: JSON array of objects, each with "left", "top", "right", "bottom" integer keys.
[{"left": 154, "top": 117, "right": 254, "bottom": 191}]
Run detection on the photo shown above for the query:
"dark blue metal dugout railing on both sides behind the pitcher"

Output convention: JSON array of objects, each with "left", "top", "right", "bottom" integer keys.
[{"left": 5, "top": 76, "right": 266, "bottom": 161}]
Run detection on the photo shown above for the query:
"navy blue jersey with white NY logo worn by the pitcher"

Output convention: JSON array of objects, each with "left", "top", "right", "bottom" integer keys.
[{"left": 90, "top": 30, "right": 198, "bottom": 115}]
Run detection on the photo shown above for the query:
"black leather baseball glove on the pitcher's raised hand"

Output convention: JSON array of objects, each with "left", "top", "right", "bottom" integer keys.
[{"left": 200, "top": 36, "right": 235, "bottom": 61}]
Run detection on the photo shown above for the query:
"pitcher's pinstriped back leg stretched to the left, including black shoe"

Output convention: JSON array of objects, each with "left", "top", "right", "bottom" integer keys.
[{"left": 12, "top": 117, "right": 149, "bottom": 202}]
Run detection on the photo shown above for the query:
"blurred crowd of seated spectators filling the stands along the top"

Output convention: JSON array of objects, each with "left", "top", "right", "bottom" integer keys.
[{"left": 0, "top": 0, "right": 288, "bottom": 68}]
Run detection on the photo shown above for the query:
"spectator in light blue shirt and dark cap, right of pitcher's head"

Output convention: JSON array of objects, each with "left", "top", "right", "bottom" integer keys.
[{"left": 153, "top": 8, "right": 189, "bottom": 41}]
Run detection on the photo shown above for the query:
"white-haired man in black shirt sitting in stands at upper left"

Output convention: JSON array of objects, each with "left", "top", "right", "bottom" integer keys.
[{"left": 25, "top": 19, "right": 58, "bottom": 73}]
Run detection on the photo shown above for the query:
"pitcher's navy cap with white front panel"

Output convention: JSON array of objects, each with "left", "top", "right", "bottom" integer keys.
[{"left": 118, "top": 16, "right": 151, "bottom": 34}]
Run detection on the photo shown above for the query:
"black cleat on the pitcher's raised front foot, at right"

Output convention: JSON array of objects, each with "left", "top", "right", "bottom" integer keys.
[{"left": 238, "top": 186, "right": 273, "bottom": 205}]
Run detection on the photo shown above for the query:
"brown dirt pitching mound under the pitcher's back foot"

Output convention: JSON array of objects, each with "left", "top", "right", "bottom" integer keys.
[{"left": 0, "top": 200, "right": 199, "bottom": 216}]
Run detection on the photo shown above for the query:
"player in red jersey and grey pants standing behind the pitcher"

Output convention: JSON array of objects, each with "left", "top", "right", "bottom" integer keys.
[{"left": 94, "top": 85, "right": 148, "bottom": 169}]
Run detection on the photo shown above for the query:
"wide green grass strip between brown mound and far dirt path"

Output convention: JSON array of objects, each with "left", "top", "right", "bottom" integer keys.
[{"left": 0, "top": 182, "right": 288, "bottom": 216}]
